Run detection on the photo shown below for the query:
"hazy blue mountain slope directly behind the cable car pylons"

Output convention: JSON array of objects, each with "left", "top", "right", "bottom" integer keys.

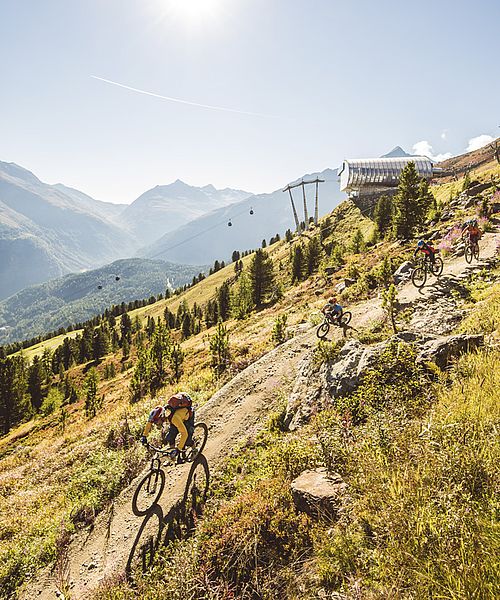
[{"left": 139, "top": 169, "right": 344, "bottom": 264}]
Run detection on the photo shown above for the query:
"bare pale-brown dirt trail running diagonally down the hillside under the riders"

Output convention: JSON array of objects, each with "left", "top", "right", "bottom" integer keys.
[{"left": 20, "top": 227, "right": 500, "bottom": 600}]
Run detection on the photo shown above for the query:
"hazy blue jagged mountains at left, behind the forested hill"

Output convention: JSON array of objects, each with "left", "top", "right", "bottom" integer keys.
[{"left": 0, "top": 162, "right": 250, "bottom": 299}]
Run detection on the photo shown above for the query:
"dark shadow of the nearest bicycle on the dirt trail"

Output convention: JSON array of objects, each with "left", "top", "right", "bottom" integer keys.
[{"left": 126, "top": 454, "right": 210, "bottom": 579}]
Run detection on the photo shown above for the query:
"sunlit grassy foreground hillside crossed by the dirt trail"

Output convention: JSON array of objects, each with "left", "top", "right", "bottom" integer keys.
[{"left": 0, "top": 146, "right": 500, "bottom": 600}]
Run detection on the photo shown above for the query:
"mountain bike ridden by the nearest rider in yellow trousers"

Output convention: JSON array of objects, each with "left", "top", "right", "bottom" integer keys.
[{"left": 132, "top": 423, "right": 208, "bottom": 517}]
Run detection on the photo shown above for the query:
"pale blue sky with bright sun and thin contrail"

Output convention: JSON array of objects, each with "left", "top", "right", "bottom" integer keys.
[{"left": 0, "top": 0, "right": 500, "bottom": 203}]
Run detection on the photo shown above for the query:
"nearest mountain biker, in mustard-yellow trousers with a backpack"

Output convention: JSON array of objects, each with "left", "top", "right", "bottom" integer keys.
[{"left": 141, "top": 392, "right": 194, "bottom": 464}]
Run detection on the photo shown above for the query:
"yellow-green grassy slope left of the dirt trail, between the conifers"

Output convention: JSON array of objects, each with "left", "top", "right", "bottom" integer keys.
[{"left": 0, "top": 162, "right": 496, "bottom": 596}]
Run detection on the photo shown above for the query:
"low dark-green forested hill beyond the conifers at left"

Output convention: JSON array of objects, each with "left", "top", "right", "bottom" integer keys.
[{"left": 0, "top": 258, "right": 207, "bottom": 345}]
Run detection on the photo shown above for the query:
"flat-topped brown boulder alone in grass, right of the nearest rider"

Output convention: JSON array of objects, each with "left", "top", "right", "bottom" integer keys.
[{"left": 291, "top": 469, "right": 347, "bottom": 519}]
